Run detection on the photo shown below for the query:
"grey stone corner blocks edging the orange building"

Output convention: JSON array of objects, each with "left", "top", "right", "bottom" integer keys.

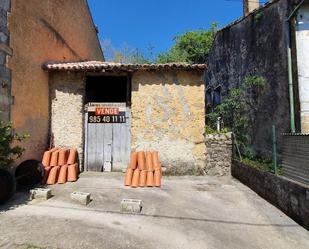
[{"left": 0, "top": 0, "right": 12, "bottom": 121}]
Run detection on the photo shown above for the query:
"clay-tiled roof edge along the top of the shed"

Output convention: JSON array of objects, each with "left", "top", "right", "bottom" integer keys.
[{"left": 43, "top": 61, "right": 207, "bottom": 72}]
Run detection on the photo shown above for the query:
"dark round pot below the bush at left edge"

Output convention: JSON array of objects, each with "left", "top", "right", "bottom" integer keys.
[{"left": 0, "top": 169, "right": 15, "bottom": 204}]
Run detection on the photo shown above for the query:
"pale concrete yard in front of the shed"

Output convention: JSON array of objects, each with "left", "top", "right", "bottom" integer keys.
[{"left": 0, "top": 173, "right": 309, "bottom": 249}]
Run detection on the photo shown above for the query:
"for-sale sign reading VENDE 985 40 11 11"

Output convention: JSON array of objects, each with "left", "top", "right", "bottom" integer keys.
[{"left": 88, "top": 103, "right": 126, "bottom": 123}]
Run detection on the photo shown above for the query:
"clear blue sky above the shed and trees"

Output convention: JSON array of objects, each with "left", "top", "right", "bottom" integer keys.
[{"left": 88, "top": 0, "right": 247, "bottom": 56}]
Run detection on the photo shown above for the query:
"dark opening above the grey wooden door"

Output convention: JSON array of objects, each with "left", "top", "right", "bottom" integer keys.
[{"left": 85, "top": 76, "right": 131, "bottom": 104}]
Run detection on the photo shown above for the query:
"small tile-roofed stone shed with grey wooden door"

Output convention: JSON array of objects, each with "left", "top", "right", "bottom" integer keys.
[{"left": 44, "top": 61, "right": 206, "bottom": 174}]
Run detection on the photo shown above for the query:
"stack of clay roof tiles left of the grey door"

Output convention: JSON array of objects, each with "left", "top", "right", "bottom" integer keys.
[{"left": 42, "top": 148, "right": 78, "bottom": 185}]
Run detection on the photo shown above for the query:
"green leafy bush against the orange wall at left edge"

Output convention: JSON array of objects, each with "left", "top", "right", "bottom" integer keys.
[{"left": 0, "top": 118, "right": 29, "bottom": 169}]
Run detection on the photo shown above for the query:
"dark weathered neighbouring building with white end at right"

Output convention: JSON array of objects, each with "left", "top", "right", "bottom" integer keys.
[{"left": 206, "top": 0, "right": 309, "bottom": 157}]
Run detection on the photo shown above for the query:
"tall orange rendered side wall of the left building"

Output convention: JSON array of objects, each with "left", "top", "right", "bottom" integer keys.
[{"left": 9, "top": 0, "right": 103, "bottom": 164}]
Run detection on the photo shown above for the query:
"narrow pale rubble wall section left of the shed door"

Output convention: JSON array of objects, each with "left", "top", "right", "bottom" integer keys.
[{"left": 50, "top": 73, "right": 85, "bottom": 167}]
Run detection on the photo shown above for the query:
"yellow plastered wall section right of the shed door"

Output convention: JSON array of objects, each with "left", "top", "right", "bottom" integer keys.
[{"left": 131, "top": 71, "right": 206, "bottom": 175}]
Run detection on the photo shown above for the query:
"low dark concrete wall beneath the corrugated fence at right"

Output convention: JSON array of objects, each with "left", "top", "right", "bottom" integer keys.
[{"left": 232, "top": 161, "right": 309, "bottom": 229}]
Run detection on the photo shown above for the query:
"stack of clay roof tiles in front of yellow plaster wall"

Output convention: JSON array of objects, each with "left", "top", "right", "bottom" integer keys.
[{"left": 124, "top": 151, "right": 162, "bottom": 188}]
